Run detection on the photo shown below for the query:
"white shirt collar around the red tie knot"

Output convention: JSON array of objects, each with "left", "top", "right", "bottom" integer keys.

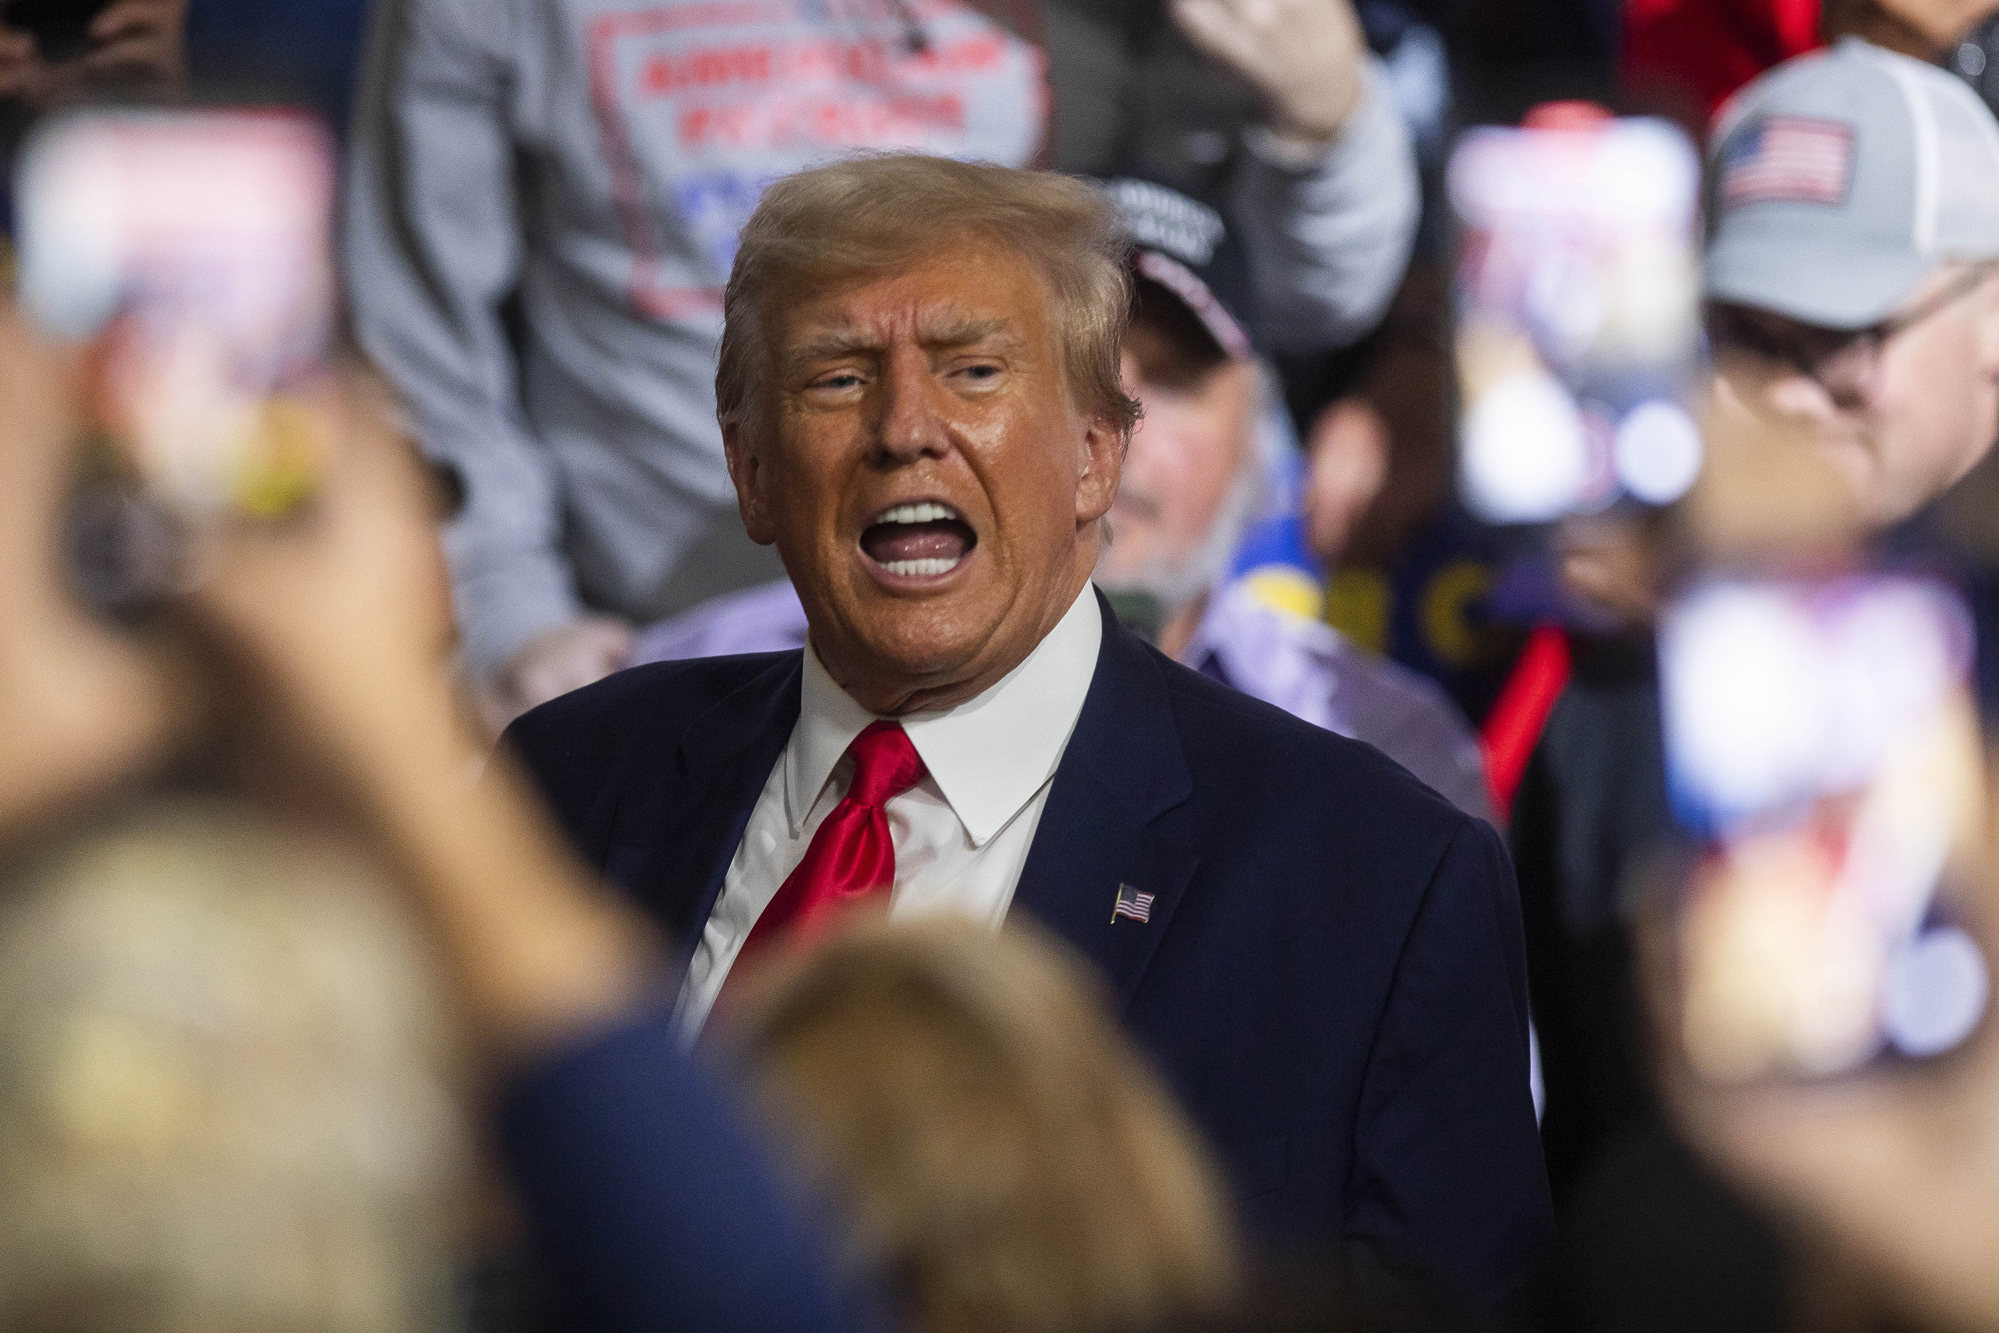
[{"left": 784, "top": 584, "right": 1103, "bottom": 847}]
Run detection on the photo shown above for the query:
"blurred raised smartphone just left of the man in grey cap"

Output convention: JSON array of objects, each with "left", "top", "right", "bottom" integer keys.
[{"left": 1447, "top": 104, "right": 1701, "bottom": 524}]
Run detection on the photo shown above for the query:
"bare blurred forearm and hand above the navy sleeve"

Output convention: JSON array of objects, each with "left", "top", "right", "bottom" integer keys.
[{"left": 178, "top": 377, "right": 658, "bottom": 1061}]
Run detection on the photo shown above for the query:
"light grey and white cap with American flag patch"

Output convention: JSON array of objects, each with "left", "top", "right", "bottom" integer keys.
[{"left": 1703, "top": 38, "right": 1999, "bottom": 328}]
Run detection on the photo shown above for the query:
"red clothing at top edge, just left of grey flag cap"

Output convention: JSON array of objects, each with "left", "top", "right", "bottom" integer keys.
[{"left": 1619, "top": 0, "right": 1821, "bottom": 118}]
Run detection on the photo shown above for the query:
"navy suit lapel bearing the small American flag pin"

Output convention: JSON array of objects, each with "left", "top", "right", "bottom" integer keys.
[{"left": 1013, "top": 596, "right": 1199, "bottom": 1007}]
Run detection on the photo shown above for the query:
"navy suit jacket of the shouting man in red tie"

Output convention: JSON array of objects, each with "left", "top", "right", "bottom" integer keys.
[{"left": 510, "top": 591, "right": 1553, "bottom": 1303}]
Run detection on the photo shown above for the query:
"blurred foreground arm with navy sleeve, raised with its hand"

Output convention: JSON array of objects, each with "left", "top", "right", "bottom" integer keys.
[{"left": 190, "top": 387, "right": 854, "bottom": 1331}]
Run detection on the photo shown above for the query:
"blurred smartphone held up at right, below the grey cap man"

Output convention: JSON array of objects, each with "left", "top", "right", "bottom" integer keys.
[{"left": 1659, "top": 574, "right": 1991, "bottom": 1081}]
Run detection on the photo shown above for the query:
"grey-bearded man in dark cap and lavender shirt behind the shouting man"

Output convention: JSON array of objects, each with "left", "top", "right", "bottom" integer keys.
[{"left": 634, "top": 180, "right": 1491, "bottom": 819}]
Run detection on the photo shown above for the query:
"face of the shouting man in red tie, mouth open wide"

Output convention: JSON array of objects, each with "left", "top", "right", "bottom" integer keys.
[{"left": 722, "top": 240, "right": 1125, "bottom": 713}]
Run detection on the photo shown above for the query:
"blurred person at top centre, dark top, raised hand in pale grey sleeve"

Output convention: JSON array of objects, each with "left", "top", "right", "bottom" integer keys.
[{"left": 1037, "top": 0, "right": 1441, "bottom": 352}]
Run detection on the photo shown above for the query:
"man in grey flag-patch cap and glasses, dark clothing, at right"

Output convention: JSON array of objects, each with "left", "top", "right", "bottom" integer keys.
[{"left": 1513, "top": 40, "right": 1999, "bottom": 1325}]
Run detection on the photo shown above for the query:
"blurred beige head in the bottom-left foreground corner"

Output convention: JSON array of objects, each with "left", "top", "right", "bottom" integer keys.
[{"left": 0, "top": 805, "right": 464, "bottom": 1333}]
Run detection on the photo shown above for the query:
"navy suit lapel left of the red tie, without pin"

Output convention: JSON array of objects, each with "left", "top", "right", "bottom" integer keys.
[{"left": 608, "top": 654, "right": 804, "bottom": 967}]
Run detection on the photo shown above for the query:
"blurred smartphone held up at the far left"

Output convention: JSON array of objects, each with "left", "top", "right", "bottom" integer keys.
[{"left": 16, "top": 110, "right": 334, "bottom": 526}]
